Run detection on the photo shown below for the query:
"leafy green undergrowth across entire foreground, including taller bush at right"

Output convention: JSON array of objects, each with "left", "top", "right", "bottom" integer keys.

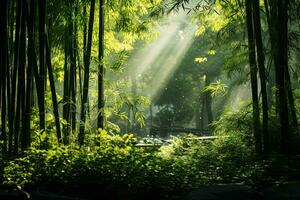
[{"left": 0, "top": 106, "right": 300, "bottom": 199}]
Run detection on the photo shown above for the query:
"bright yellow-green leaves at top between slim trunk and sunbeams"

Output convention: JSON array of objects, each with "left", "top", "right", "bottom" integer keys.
[{"left": 105, "top": 0, "right": 160, "bottom": 52}]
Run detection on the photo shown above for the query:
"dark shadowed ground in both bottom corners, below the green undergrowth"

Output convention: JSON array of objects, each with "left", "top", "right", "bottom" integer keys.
[{"left": 0, "top": 181, "right": 300, "bottom": 200}]
